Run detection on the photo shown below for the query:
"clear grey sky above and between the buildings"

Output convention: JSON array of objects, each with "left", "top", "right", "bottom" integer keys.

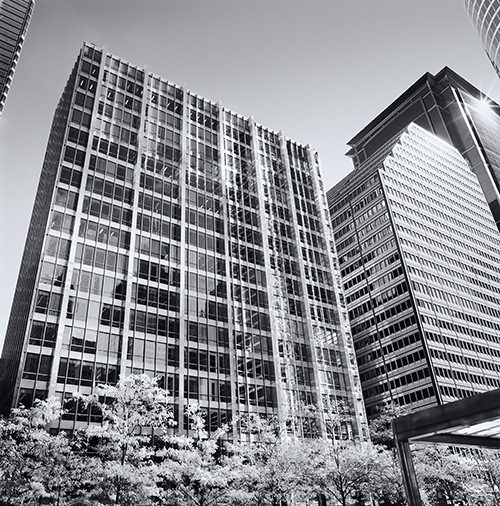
[{"left": 0, "top": 0, "right": 500, "bottom": 343}]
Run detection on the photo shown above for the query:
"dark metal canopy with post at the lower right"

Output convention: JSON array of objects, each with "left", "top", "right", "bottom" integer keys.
[{"left": 392, "top": 389, "right": 500, "bottom": 506}]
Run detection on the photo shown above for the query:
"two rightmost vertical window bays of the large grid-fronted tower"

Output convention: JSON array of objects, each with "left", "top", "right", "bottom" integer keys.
[{"left": 249, "top": 126, "right": 364, "bottom": 437}]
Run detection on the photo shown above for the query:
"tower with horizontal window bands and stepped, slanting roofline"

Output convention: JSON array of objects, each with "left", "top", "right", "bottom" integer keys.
[{"left": 330, "top": 124, "right": 500, "bottom": 415}]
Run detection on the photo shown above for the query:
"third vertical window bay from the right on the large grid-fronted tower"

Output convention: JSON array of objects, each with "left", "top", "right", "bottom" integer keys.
[{"left": 227, "top": 116, "right": 278, "bottom": 422}]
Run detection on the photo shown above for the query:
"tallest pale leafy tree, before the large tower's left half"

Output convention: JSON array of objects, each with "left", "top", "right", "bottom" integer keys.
[{"left": 77, "top": 374, "right": 173, "bottom": 505}]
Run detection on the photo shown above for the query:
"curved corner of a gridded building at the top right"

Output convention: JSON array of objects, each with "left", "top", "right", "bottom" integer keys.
[{"left": 461, "top": 0, "right": 500, "bottom": 76}]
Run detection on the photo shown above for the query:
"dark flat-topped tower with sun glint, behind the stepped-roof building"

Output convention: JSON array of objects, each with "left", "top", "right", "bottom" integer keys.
[{"left": 347, "top": 67, "right": 500, "bottom": 229}]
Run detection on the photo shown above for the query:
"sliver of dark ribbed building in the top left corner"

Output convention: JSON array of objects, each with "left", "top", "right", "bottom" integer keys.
[{"left": 0, "top": 0, "right": 35, "bottom": 116}]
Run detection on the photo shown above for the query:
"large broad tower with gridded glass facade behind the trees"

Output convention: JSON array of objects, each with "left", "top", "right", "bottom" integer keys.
[{"left": 2, "top": 44, "right": 364, "bottom": 437}]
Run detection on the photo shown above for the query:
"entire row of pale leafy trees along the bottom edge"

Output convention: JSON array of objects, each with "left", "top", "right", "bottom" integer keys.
[{"left": 0, "top": 375, "right": 500, "bottom": 506}]
